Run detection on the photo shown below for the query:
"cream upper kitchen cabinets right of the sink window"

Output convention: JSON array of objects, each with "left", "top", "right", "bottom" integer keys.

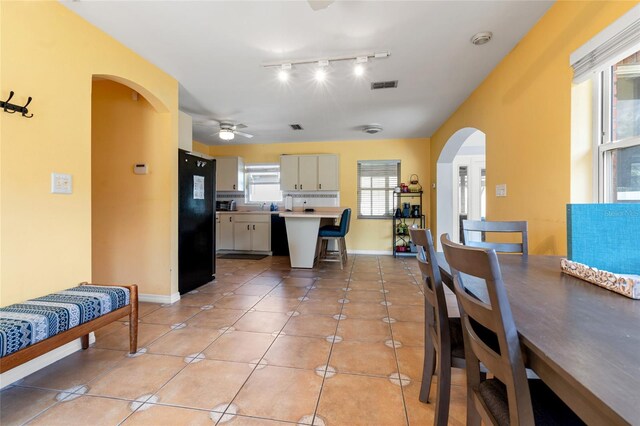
[{"left": 280, "top": 154, "right": 340, "bottom": 191}]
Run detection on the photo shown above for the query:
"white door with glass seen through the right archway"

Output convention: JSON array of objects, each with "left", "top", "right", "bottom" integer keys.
[{"left": 452, "top": 155, "right": 486, "bottom": 243}]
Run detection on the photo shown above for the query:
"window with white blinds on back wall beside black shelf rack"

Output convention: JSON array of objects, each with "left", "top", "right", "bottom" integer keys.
[{"left": 358, "top": 160, "right": 400, "bottom": 219}]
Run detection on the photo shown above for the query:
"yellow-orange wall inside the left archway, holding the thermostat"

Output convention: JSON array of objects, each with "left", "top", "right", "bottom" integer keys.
[{"left": 91, "top": 80, "right": 174, "bottom": 294}]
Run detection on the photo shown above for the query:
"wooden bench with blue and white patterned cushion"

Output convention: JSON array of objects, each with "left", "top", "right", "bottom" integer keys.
[{"left": 0, "top": 283, "right": 138, "bottom": 373}]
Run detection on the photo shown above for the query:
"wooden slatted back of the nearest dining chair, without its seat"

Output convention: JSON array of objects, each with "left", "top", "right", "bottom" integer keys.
[{"left": 440, "top": 234, "right": 534, "bottom": 425}]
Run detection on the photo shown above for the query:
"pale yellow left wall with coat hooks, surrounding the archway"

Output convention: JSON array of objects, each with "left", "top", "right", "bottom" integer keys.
[{"left": 0, "top": 1, "right": 178, "bottom": 305}]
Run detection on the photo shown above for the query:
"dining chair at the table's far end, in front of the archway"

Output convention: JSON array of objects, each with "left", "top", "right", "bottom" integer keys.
[{"left": 462, "top": 220, "right": 529, "bottom": 255}]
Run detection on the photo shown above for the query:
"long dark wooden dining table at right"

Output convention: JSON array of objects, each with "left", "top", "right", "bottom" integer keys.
[{"left": 437, "top": 253, "right": 640, "bottom": 425}]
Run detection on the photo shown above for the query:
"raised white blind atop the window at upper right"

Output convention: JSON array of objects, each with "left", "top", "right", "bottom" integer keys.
[{"left": 570, "top": 5, "right": 640, "bottom": 83}]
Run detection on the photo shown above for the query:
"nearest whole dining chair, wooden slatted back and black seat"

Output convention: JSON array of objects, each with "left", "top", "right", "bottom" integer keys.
[{"left": 440, "top": 234, "right": 584, "bottom": 426}]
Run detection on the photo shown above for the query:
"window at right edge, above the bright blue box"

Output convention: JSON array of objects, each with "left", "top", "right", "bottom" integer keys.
[{"left": 597, "top": 51, "right": 640, "bottom": 203}]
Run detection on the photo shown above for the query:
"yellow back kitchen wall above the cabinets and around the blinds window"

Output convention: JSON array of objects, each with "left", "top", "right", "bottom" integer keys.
[{"left": 209, "top": 138, "right": 429, "bottom": 251}]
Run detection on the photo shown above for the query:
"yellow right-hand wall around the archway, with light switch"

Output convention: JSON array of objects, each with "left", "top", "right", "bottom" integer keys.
[{"left": 431, "top": 1, "right": 637, "bottom": 254}]
